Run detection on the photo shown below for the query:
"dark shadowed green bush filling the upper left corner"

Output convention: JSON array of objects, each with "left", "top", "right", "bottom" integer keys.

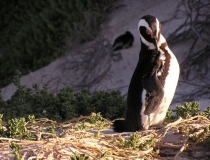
[{"left": 0, "top": 0, "right": 116, "bottom": 87}]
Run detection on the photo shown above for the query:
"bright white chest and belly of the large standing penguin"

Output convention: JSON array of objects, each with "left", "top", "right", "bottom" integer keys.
[{"left": 140, "top": 47, "right": 180, "bottom": 129}]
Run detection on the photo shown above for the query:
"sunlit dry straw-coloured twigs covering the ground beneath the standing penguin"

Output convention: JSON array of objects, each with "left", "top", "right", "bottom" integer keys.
[{"left": 0, "top": 114, "right": 210, "bottom": 160}]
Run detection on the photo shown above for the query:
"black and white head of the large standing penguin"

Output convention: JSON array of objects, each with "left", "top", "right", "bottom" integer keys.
[{"left": 138, "top": 15, "right": 161, "bottom": 49}]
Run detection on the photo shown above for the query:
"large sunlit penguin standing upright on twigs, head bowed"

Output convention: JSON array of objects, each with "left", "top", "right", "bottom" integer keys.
[{"left": 113, "top": 15, "right": 180, "bottom": 132}]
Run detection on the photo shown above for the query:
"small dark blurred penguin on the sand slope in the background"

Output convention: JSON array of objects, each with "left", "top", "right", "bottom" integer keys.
[{"left": 112, "top": 31, "right": 134, "bottom": 51}]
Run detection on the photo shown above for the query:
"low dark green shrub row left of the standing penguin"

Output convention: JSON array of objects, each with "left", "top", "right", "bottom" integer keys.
[{"left": 0, "top": 77, "right": 126, "bottom": 122}]
